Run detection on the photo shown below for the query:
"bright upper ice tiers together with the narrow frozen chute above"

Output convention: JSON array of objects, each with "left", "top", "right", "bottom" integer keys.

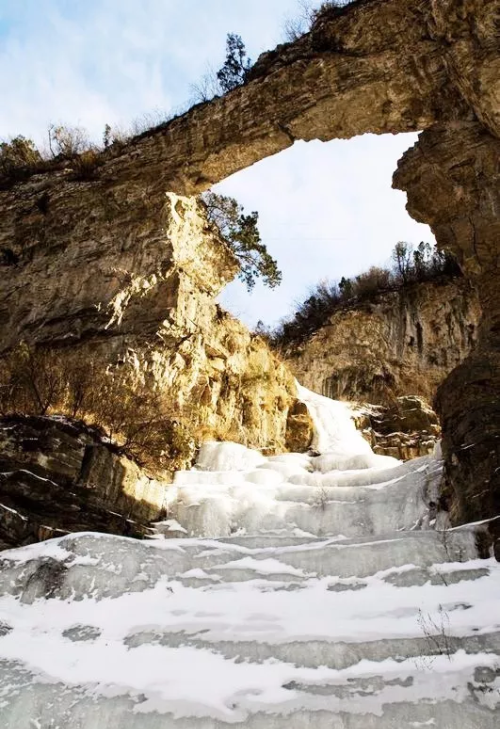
[{"left": 165, "top": 386, "right": 430, "bottom": 538}]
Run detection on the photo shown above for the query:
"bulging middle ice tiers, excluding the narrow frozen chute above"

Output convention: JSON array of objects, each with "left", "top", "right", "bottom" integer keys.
[{"left": 164, "top": 456, "right": 442, "bottom": 538}]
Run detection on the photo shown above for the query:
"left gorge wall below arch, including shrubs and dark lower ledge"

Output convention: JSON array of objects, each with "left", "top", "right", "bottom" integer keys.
[{"left": 0, "top": 189, "right": 298, "bottom": 547}]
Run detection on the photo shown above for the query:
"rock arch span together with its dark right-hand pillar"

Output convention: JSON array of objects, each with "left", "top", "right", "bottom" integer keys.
[{"left": 0, "top": 0, "right": 500, "bottom": 519}]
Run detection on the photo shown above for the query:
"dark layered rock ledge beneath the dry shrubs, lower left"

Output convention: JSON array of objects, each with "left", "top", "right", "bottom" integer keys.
[{"left": 0, "top": 416, "right": 168, "bottom": 548}]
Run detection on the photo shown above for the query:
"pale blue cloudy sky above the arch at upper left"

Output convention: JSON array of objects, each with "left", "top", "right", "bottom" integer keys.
[{"left": 0, "top": 0, "right": 294, "bottom": 140}]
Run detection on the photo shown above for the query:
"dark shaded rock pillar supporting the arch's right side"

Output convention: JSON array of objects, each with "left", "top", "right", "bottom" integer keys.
[{"left": 394, "top": 122, "right": 500, "bottom": 529}]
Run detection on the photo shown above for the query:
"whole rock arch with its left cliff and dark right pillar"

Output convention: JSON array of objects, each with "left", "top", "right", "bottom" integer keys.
[{"left": 0, "top": 0, "right": 500, "bottom": 536}]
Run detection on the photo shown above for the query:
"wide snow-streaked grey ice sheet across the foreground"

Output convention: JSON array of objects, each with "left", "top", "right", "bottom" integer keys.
[{"left": 0, "top": 532, "right": 500, "bottom": 729}]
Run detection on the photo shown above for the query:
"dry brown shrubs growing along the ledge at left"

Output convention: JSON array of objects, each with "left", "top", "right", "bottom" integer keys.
[{"left": 0, "top": 344, "right": 195, "bottom": 472}]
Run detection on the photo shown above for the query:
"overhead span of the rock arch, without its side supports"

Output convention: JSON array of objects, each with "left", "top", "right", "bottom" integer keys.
[{"left": 94, "top": 0, "right": 484, "bottom": 194}]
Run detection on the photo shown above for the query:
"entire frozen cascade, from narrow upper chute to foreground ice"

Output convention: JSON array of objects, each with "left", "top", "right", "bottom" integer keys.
[{"left": 0, "top": 390, "right": 500, "bottom": 729}]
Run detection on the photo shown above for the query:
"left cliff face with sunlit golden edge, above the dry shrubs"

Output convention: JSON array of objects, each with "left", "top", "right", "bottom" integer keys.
[{"left": 0, "top": 191, "right": 295, "bottom": 465}]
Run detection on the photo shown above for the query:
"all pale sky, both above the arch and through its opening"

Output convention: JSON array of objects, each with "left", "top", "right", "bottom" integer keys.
[{"left": 0, "top": 0, "right": 433, "bottom": 326}]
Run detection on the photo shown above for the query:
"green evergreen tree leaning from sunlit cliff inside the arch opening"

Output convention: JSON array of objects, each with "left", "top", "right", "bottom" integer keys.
[{"left": 201, "top": 192, "right": 281, "bottom": 291}]
